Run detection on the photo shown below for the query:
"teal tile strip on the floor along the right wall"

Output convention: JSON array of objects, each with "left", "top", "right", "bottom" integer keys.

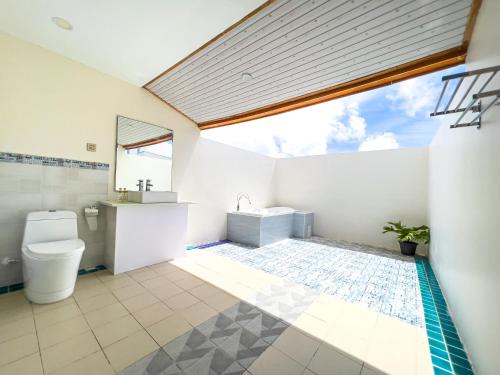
[{"left": 415, "top": 257, "right": 474, "bottom": 375}]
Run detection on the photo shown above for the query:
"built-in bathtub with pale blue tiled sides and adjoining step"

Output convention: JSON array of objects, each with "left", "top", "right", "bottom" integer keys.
[{"left": 227, "top": 207, "right": 313, "bottom": 247}]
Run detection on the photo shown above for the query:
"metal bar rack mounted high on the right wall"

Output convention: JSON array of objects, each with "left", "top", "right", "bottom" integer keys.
[{"left": 430, "top": 65, "right": 500, "bottom": 129}]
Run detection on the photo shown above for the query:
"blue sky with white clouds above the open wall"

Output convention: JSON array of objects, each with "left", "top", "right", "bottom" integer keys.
[{"left": 201, "top": 66, "right": 464, "bottom": 158}]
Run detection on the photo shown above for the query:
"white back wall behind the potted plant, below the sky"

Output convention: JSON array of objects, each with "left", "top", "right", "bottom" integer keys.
[{"left": 275, "top": 148, "right": 427, "bottom": 251}]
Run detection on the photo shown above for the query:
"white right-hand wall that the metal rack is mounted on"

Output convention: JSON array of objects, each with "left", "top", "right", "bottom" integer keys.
[{"left": 429, "top": 0, "right": 500, "bottom": 374}]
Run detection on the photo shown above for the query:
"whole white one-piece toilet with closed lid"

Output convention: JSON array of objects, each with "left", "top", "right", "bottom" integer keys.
[{"left": 22, "top": 211, "right": 85, "bottom": 304}]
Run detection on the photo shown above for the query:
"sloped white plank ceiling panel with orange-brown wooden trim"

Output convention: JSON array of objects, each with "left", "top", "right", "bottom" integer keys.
[{"left": 144, "top": 0, "right": 480, "bottom": 129}]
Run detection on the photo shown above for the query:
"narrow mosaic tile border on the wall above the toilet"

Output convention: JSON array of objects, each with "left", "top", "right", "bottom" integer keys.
[{"left": 0, "top": 152, "right": 109, "bottom": 171}]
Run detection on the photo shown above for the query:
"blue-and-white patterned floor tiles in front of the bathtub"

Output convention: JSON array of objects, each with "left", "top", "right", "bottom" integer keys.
[{"left": 205, "top": 237, "right": 424, "bottom": 327}]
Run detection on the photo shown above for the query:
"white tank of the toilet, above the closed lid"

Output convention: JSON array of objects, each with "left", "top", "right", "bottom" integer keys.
[{"left": 23, "top": 210, "right": 78, "bottom": 247}]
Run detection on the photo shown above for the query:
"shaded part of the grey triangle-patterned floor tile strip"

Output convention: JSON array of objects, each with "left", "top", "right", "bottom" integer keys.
[{"left": 120, "top": 301, "right": 289, "bottom": 375}]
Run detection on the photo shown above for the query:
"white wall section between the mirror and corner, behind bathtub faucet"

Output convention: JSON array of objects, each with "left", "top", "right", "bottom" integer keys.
[{"left": 179, "top": 138, "right": 275, "bottom": 244}]
